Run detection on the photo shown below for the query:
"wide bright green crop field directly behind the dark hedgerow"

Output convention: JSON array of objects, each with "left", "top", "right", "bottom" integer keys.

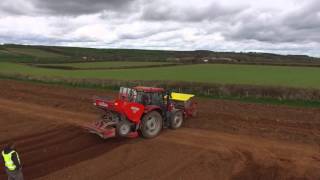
[{"left": 0, "top": 63, "right": 320, "bottom": 89}]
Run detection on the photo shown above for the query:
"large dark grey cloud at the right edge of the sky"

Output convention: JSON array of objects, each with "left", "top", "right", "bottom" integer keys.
[{"left": 224, "top": 1, "right": 320, "bottom": 44}]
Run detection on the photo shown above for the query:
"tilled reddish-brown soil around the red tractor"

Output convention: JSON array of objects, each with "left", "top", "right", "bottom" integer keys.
[{"left": 0, "top": 80, "right": 320, "bottom": 180}]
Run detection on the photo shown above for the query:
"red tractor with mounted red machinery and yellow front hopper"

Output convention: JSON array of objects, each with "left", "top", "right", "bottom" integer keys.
[{"left": 86, "top": 86, "right": 197, "bottom": 139}]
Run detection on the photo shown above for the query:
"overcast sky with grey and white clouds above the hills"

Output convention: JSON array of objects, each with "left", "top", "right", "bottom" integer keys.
[{"left": 0, "top": 0, "right": 320, "bottom": 56}]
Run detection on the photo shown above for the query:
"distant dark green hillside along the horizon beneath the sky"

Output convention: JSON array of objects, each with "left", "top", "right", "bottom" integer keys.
[{"left": 0, "top": 44, "right": 320, "bottom": 66}]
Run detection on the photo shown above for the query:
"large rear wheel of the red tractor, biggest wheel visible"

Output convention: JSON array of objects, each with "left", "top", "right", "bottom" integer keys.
[{"left": 140, "top": 111, "right": 163, "bottom": 138}]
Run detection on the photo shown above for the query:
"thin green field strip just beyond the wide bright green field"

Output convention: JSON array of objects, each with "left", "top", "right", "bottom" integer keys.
[{"left": 38, "top": 61, "right": 171, "bottom": 69}]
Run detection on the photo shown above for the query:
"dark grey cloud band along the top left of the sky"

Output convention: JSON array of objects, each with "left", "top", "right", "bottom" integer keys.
[{"left": 0, "top": 0, "right": 136, "bottom": 16}]
